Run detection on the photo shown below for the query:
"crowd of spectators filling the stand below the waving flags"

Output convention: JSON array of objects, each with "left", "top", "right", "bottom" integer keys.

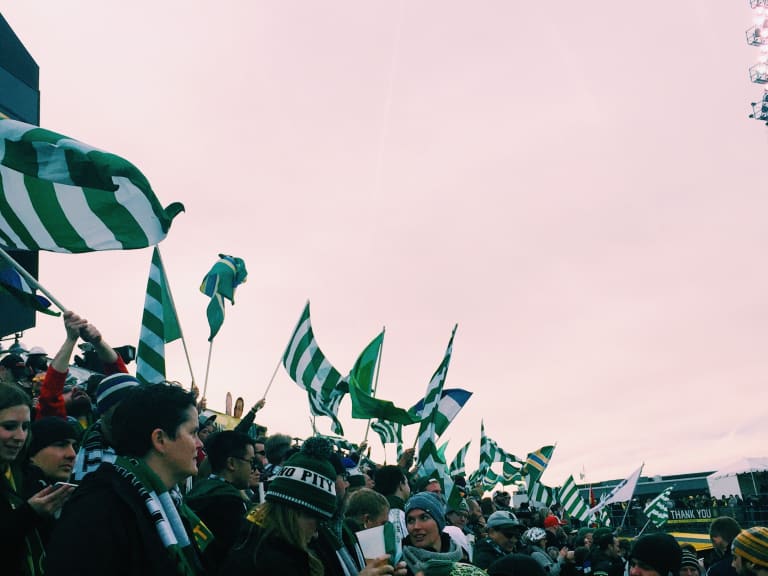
[{"left": 0, "top": 312, "right": 768, "bottom": 576}]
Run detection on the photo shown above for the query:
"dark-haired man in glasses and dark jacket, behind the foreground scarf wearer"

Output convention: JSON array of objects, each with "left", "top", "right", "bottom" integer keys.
[{"left": 186, "top": 430, "right": 260, "bottom": 574}]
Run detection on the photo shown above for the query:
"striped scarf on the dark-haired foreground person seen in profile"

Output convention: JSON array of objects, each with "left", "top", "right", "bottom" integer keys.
[{"left": 114, "top": 456, "right": 213, "bottom": 576}]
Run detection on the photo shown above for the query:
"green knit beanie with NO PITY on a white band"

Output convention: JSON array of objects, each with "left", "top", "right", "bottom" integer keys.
[{"left": 266, "top": 436, "right": 337, "bottom": 519}]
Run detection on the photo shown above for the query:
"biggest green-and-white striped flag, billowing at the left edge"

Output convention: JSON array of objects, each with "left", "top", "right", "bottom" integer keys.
[{"left": 0, "top": 117, "right": 184, "bottom": 252}]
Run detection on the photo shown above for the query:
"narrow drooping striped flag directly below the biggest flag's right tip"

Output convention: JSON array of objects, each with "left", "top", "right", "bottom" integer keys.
[{"left": 136, "top": 246, "right": 181, "bottom": 384}]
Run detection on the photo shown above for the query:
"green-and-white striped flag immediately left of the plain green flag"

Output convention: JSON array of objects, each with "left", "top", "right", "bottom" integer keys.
[{"left": 283, "top": 302, "right": 347, "bottom": 436}]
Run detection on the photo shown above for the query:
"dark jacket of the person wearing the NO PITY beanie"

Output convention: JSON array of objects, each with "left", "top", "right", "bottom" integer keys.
[{"left": 218, "top": 522, "right": 309, "bottom": 576}]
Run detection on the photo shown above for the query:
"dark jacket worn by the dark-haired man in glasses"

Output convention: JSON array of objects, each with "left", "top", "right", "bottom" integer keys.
[{"left": 185, "top": 478, "right": 248, "bottom": 573}]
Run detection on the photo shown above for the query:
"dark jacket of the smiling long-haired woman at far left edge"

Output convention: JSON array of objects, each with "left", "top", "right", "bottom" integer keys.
[{"left": 0, "top": 469, "right": 45, "bottom": 576}]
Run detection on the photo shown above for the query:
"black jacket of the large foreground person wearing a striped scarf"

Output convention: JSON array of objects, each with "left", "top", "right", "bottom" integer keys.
[{"left": 46, "top": 463, "right": 204, "bottom": 576}]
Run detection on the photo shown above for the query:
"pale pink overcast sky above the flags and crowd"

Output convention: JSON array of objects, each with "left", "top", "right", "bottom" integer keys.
[{"left": 3, "top": 0, "right": 768, "bottom": 485}]
